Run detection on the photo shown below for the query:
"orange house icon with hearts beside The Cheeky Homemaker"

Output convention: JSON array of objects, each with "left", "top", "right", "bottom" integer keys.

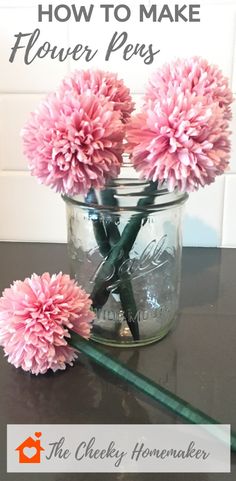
[{"left": 16, "top": 433, "right": 45, "bottom": 464}]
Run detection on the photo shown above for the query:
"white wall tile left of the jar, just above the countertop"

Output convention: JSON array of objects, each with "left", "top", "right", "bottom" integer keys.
[{"left": 0, "top": 172, "right": 66, "bottom": 242}]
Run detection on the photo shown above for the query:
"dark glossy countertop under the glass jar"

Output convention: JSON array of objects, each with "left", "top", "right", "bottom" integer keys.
[{"left": 0, "top": 243, "right": 236, "bottom": 481}]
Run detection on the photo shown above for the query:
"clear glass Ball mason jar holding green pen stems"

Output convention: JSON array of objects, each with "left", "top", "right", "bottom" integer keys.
[{"left": 64, "top": 165, "right": 187, "bottom": 346}]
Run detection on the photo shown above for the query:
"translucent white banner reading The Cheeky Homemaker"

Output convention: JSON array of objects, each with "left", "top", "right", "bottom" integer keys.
[{"left": 7, "top": 424, "right": 230, "bottom": 473}]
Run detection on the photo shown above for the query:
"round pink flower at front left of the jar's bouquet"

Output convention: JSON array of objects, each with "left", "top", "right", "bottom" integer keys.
[{"left": 22, "top": 90, "right": 125, "bottom": 196}]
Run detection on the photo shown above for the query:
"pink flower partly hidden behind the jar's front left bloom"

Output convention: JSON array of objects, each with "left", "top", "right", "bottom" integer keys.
[{"left": 60, "top": 70, "right": 134, "bottom": 123}]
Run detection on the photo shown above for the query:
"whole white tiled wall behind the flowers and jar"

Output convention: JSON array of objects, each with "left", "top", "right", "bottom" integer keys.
[{"left": 0, "top": 0, "right": 236, "bottom": 247}]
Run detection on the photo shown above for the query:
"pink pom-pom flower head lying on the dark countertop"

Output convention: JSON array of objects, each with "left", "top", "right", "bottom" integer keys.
[{"left": 0, "top": 273, "right": 94, "bottom": 374}]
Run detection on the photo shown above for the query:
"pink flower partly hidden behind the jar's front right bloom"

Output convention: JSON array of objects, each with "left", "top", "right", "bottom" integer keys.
[{"left": 145, "top": 57, "right": 233, "bottom": 120}]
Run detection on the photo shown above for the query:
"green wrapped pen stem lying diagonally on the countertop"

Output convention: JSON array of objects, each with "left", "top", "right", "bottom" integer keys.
[{"left": 68, "top": 331, "right": 236, "bottom": 451}]
